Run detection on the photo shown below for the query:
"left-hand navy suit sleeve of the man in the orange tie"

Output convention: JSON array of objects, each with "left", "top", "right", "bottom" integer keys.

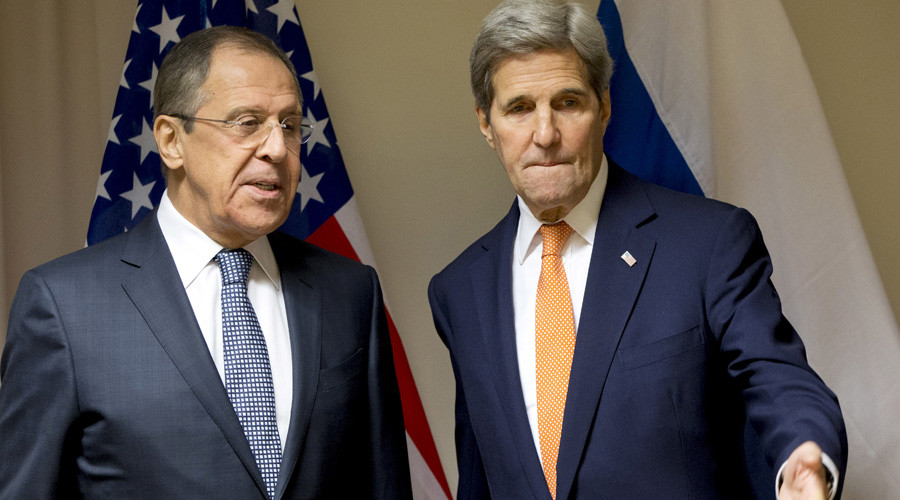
[{"left": 428, "top": 278, "right": 491, "bottom": 500}]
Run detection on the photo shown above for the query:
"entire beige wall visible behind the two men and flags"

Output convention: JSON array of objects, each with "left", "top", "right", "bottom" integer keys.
[{"left": 0, "top": 0, "right": 900, "bottom": 492}]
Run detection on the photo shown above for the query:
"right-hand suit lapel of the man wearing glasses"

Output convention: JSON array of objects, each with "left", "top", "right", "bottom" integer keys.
[{"left": 269, "top": 235, "right": 322, "bottom": 498}]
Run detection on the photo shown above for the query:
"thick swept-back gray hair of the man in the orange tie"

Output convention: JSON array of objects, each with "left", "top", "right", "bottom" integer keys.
[{"left": 469, "top": 0, "right": 613, "bottom": 120}]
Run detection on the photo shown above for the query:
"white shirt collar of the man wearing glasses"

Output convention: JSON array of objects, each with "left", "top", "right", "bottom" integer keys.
[{"left": 156, "top": 190, "right": 281, "bottom": 290}]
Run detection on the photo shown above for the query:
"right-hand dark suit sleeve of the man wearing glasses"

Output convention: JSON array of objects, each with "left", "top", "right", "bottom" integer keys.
[{"left": 369, "top": 270, "right": 412, "bottom": 500}]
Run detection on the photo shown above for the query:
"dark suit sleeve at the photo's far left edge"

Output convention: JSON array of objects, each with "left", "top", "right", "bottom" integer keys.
[{"left": 0, "top": 271, "right": 79, "bottom": 498}]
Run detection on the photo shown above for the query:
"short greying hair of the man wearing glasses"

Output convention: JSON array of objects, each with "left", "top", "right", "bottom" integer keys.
[{"left": 153, "top": 26, "right": 303, "bottom": 132}]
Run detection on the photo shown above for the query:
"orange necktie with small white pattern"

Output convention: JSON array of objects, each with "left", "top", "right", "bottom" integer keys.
[{"left": 535, "top": 222, "right": 575, "bottom": 498}]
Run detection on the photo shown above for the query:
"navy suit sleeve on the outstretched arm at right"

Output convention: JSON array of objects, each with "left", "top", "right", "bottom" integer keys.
[{"left": 706, "top": 209, "right": 847, "bottom": 491}]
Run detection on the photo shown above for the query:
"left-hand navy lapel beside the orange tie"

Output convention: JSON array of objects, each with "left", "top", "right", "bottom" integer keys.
[{"left": 471, "top": 202, "right": 549, "bottom": 498}]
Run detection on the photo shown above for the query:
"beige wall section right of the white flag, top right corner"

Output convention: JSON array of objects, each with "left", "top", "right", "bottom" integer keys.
[{"left": 782, "top": 0, "right": 900, "bottom": 326}]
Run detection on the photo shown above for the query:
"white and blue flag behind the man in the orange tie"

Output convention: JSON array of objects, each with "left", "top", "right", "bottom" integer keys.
[{"left": 597, "top": 0, "right": 900, "bottom": 498}]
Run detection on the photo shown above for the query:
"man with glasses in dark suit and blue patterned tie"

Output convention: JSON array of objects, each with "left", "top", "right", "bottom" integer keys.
[{"left": 0, "top": 27, "right": 411, "bottom": 499}]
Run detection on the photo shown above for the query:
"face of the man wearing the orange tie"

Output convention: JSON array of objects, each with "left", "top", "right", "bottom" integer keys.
[{"left": 476, "top": 49, "right": 610, "bottom": 222}]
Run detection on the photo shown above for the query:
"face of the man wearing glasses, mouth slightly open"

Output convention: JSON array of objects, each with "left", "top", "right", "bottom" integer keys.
[{"left": 166, "top": 46, "right": 302, "bottom": 248}]
